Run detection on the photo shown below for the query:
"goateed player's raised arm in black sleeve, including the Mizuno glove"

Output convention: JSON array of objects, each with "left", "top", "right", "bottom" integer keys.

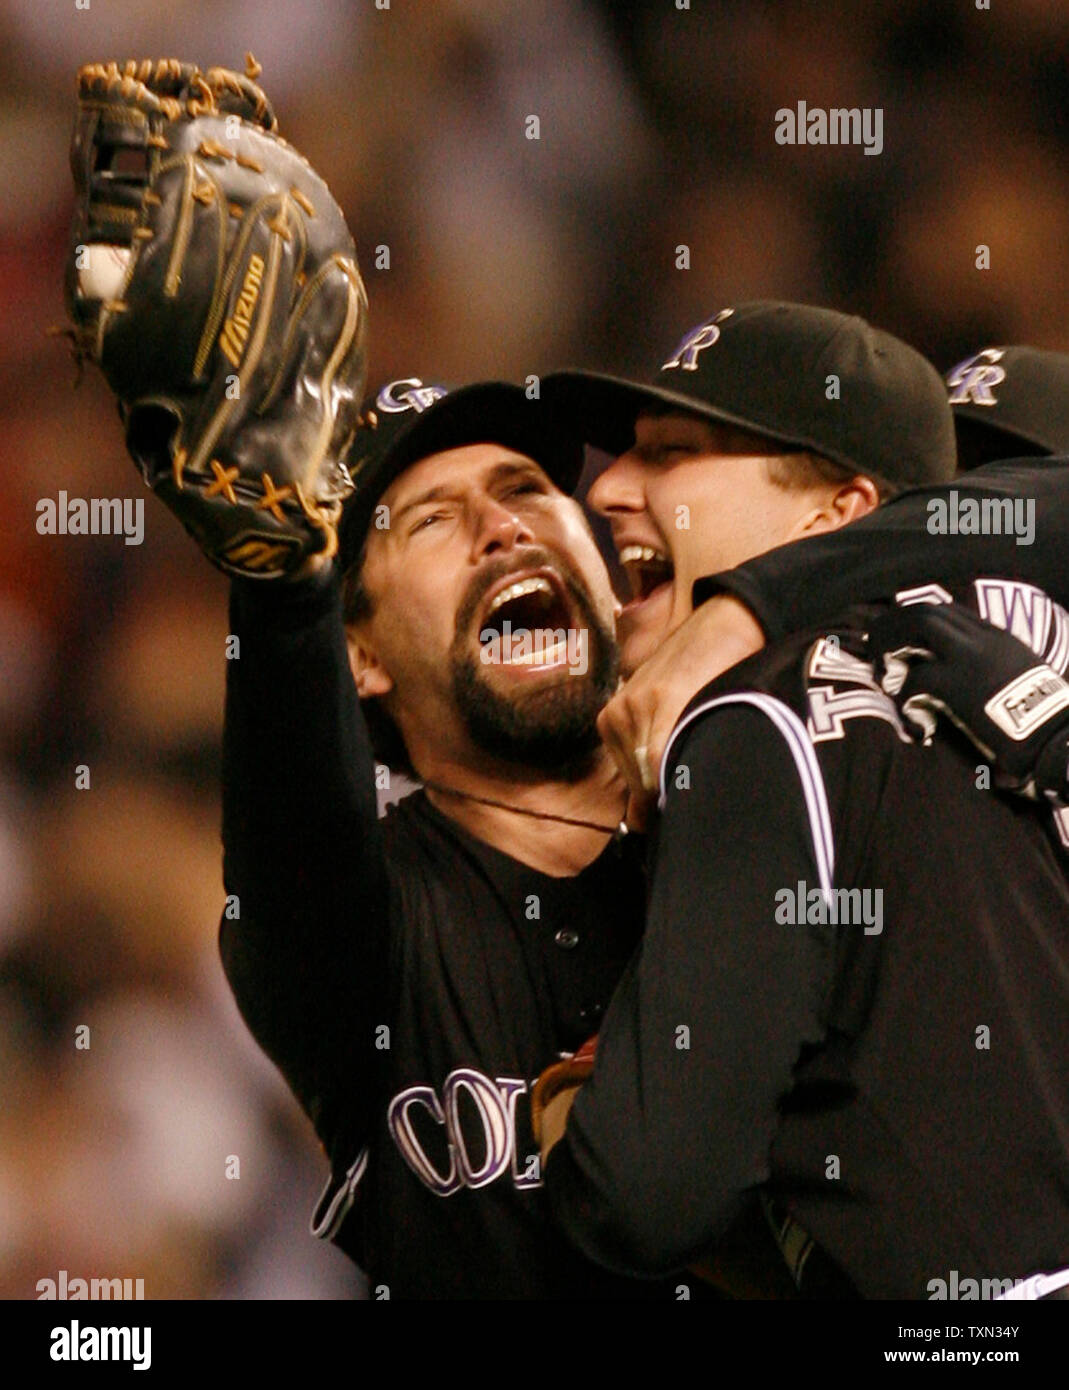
[{"left": 58, "top": 57, "right": 386, "bottom": 1156}]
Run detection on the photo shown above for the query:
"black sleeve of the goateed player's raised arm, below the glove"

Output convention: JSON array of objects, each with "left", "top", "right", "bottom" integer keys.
[{"left": 220, "top": 578, "right": 389, "bottom": 1165}]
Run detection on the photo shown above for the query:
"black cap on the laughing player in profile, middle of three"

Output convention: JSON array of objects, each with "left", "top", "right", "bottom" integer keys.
[{"left": 542, "top": 300, "right": 956, "bottom": 488}]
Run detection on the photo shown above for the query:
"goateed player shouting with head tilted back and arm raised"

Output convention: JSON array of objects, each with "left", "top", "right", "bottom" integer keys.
[{"left": 221, "top": 377, "right": 675, "bottom": 1297}]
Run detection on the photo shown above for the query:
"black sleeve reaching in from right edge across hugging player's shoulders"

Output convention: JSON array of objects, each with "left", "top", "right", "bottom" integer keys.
[{"left": 694, "top": 459, "right": 1069, "bottom": 642}]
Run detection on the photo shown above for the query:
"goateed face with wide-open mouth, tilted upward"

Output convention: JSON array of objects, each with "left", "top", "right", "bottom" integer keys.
[{"left": 350, "top": 443, "right": 616, "bottom": 770}]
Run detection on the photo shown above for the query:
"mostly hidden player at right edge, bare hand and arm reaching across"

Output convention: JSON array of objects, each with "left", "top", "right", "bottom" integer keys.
[{"left": 592, "top": 346, "right": 1069, "bottom": 824}]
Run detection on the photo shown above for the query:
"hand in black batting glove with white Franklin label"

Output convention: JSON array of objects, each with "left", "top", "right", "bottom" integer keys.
[{"left": 869, "top": 603, "right": 1069, "bottom": 805}]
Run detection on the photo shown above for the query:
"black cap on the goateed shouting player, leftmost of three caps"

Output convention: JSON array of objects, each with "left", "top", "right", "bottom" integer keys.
[{"left": 339, "top": 377, "right": 582, "bottom": 569}]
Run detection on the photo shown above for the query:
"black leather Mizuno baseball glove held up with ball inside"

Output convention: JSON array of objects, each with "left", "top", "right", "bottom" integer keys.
[{"left": 65, "top": 56, "right": 367, "bottom": 578}]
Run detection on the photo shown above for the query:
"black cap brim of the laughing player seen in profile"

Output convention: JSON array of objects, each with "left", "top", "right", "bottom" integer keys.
[{"left": 542, "top": 371, "right": 810, "bottom": 455}]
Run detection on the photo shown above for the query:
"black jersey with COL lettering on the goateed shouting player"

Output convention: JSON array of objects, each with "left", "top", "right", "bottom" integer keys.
[{"left": 221, "top": 582, "right": 692, "bottom": 1298}]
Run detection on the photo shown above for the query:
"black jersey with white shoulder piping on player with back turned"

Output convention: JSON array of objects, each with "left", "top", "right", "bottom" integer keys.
[{"left": 545, "top": 630, "right": 1069, "bottom": 1298}]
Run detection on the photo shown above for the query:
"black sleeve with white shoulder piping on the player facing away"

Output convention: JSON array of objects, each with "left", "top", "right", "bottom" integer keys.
[{"left": 545, "top": 702, "right": 833, "bottom": 1275}]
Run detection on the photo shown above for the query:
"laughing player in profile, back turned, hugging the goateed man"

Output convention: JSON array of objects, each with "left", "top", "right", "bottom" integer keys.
[{"left": 545, "top": 306, "right": 1069, "bottom": 1298}]
